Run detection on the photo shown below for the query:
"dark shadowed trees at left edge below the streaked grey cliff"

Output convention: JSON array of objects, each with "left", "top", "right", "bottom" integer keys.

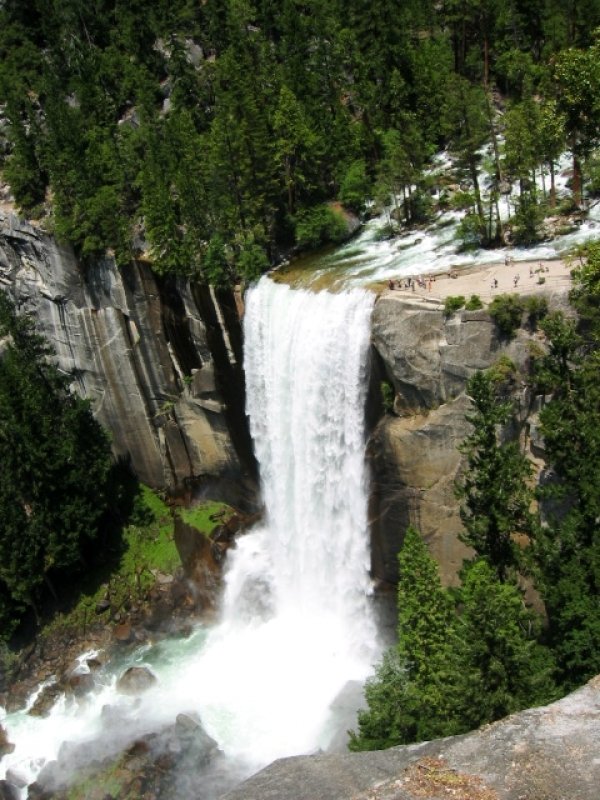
[{"left": 0, "top": 293, "right": 112, "bottom": 630}]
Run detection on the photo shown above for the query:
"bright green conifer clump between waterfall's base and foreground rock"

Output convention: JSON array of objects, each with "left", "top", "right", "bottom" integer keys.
[{"left": 349, "top": 528, "right": 555, "bottom": 751}]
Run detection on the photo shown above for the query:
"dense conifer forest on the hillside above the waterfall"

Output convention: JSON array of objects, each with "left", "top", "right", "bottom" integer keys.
[{"left": 0, "top": 0, "right": 600, "bottom": 284}]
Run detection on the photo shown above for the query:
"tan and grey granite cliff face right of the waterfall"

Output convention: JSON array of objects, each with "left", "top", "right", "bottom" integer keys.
[{"left": 369, "top": 293, "right": 566, "bottom": 584}]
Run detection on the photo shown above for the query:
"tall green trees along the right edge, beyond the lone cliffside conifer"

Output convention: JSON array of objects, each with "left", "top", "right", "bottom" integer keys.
[{"left": 536, "top": 245, "right": 600, "bottom": 688}]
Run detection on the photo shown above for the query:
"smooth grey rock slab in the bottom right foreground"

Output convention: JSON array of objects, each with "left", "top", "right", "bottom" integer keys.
[{"left": 225, "top": 676, "right": 600, "bottom": 800}]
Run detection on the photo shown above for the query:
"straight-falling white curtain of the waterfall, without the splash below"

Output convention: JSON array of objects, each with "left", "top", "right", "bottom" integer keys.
[{"left": 244, "top": 279, "right": 373, "bottom": 642}]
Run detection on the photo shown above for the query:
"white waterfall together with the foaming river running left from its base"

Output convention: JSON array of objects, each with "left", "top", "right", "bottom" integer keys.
[{"left": 0, "top": 278, "right": 378, "bottom": 797}]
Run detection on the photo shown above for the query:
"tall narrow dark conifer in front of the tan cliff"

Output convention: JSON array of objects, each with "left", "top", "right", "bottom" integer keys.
[{"left": 456, "top": 372, "right": 534, "bottom": 580}]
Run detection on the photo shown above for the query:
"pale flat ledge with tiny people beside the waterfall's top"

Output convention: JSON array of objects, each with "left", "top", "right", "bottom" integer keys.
[{"left": 385, "top": 259, "right": 571, "bottom": 302}]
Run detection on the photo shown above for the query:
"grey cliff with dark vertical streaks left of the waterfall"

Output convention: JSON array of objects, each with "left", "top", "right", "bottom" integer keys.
[{"left": 0, "top": 211, "right": 253, "bottom": 494}]
